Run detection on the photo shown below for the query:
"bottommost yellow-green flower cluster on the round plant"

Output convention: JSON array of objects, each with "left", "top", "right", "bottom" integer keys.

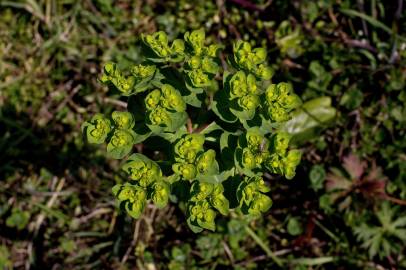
[{"left": 188, "top": 181, "right": 229, "bottom": 231}]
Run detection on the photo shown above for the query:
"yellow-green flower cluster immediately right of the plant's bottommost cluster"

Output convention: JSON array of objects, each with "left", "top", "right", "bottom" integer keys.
[{"left": 237, "top": 176, "right": 272, "bottom": 216}]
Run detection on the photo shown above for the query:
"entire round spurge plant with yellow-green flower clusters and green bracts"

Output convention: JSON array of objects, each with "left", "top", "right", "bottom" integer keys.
[{"left": 82, "top": 29, "right": 301, "bottom": 232}]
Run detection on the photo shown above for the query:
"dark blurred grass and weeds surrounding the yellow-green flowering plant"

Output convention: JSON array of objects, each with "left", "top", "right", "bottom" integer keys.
[{"left": 0, "top": 0, "right": 406, "bottom": 269}]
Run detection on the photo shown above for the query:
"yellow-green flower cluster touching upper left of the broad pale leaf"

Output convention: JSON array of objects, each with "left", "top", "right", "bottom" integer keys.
[{"left": 265, "top": 82, "right": 301, "bottom": 122}]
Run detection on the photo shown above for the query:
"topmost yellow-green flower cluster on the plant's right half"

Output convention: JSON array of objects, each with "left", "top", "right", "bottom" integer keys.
[{"left": 233, "top": 40, "right": 273, "bottom": 80}]
